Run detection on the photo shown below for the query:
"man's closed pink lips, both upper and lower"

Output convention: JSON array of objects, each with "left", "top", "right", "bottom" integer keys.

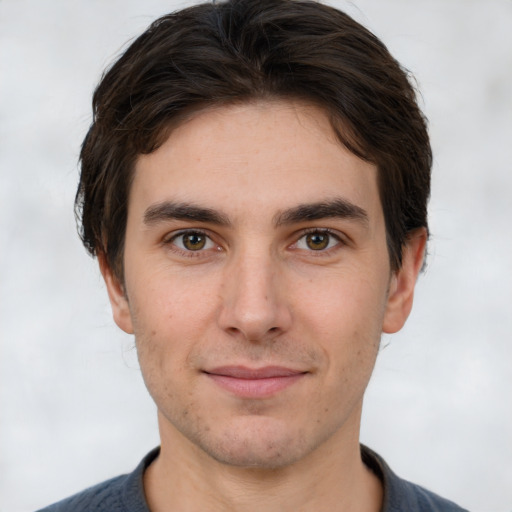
[{"left": 204, "top": 366, "right": 307, "bottom": 398}]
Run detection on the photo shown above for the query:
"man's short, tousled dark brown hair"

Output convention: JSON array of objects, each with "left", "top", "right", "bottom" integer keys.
[{"left": 76, "top": 0, "right": 432, "bottom": 282}]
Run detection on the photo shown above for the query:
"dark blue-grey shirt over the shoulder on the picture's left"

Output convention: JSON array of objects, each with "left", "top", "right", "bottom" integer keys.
[{"left": 34, "top": 448, "right": 160, "bottom": 512}]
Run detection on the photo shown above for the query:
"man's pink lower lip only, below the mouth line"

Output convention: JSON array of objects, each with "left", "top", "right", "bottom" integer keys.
[{"left": 207, "top": 373, "right": 305, "bottom": 398}]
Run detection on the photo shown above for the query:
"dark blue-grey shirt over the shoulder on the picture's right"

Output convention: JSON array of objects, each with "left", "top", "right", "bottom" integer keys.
[{"left": 361, "top": 446, "right": 467, "bottom": 512}]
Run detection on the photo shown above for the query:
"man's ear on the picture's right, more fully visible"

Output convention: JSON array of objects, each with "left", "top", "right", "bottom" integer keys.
[{"left": 382, "top": 228, "right": 427, "bottom": 334}]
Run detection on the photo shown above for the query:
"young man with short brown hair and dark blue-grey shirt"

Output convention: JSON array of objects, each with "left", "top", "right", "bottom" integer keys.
[{"left": 39, "top": 0, "right": 468, "bottom": 512}]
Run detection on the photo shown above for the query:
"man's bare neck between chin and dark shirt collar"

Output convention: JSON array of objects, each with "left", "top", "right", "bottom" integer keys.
[{"left": 144, "top": 412, "right": 382, "bottom": 512}]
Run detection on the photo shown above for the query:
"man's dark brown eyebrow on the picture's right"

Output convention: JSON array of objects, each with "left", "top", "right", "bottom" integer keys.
[{"left": 274, "top": 198, "right": 369, "bottom": 226}]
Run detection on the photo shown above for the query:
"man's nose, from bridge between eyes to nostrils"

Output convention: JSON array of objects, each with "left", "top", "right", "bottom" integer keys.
[{"left": 219, "top": 246, "right": 292, "bottom": 343}]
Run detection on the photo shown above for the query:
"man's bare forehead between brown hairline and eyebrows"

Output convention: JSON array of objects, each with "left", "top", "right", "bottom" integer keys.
[{"left": 129, "top": 101, "right": 380, "bottom": 224}]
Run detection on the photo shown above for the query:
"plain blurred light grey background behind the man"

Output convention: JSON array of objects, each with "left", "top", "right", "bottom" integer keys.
[{"left": 0, "top": 0, "right": 512, "bottom": 512}]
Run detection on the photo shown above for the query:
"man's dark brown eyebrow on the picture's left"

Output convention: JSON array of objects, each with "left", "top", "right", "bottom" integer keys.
[{"left": 144, "top": 201, "right": 231, "bottom": 226}]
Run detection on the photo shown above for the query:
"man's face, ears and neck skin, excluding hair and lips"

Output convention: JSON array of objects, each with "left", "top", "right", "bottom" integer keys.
[{"left": 100, "top": 101, "right": 426, "bottom": 511}]
